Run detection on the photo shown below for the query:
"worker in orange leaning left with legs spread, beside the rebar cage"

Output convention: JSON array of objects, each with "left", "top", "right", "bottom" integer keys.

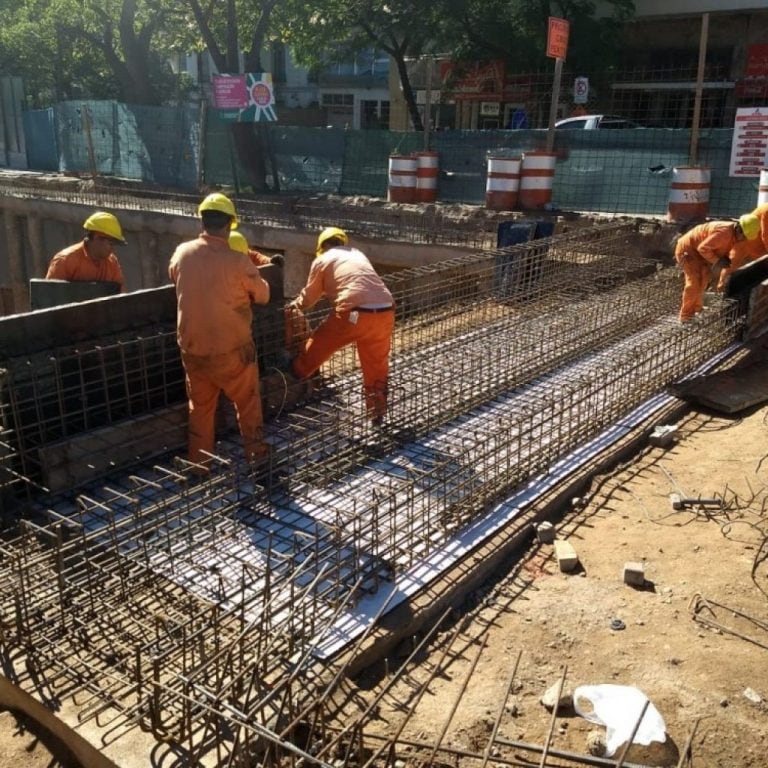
[{"left": 290, "top": 227, "right": 395, "bottom": 425}]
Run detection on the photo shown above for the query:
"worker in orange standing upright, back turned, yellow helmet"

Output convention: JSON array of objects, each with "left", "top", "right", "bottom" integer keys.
[{"left": 168, "top": 192, "right": 269, "bottom": 465}]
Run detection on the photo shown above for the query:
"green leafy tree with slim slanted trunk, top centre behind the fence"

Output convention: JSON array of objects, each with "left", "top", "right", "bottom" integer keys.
[{"left": 284, "top": 0, "right": 447, "bottom": 131}]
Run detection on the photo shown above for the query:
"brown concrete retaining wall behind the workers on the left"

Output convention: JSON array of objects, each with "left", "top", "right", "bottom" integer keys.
[{"left": 0, "top": 196, "right": 474, "bottom": 314}]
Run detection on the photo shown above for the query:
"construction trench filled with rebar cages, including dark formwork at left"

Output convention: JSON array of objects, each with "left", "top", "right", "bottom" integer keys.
[{"left": 0, "top": 190, "right": 766, "bottom": 768}]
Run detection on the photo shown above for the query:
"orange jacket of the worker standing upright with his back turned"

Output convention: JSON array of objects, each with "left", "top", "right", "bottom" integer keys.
[{"left": 168, "top": 233, "right": 269, "bottom": 356}]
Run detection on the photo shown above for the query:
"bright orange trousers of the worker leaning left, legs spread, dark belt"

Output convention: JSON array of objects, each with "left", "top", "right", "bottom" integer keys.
[{"left": 293, "top": 309, "right": 395, "bottom": 419}]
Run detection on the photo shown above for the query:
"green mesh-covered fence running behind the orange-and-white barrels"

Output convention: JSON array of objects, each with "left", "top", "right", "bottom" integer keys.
[{"left": 15, "top": 94, "right": 758, "bottom": 216}]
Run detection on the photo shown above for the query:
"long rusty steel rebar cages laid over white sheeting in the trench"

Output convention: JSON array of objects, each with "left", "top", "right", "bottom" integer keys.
[{"left": 0, "top": 219, "right": 737, "bottom": 765}]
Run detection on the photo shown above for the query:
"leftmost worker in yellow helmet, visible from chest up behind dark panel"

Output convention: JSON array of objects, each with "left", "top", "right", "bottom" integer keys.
[{"left": 45, "top": 211, "right": 125, "bottom": 291}]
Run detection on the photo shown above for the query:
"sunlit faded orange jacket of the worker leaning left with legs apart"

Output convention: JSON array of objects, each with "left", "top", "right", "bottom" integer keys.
[{"left": 294, "top": 246, "right": 394, "bottom": 312}]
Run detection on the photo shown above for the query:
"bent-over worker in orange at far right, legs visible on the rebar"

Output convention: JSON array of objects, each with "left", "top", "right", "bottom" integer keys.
[{"left": 675, "top": 213, "right": 760, "bottom": 322}]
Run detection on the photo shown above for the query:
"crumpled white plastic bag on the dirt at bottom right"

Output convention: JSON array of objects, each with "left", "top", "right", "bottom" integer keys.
[{"left": 573, "top": 684, "right": 667, "bottom": 757}]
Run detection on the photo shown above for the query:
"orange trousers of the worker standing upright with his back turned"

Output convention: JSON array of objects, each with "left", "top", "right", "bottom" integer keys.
[{"left": 181, "top": 344, "right": 266, "bottom": 464}]
